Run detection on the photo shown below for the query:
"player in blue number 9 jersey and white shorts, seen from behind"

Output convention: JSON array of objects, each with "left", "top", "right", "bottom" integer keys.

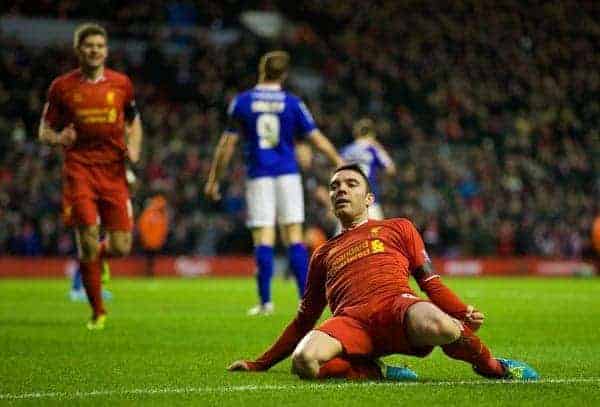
[{"left": 205, "top": 51, "right": 341, "bottom": 315}]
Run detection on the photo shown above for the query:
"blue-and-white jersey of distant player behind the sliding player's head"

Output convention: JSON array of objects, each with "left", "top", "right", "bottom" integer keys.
[{"left": 341, "top": 139, "right": 390, "bottom": 201}]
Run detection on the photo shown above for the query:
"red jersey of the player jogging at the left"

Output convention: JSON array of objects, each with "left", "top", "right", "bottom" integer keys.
[{"left": 43, "top": 68, "right": 133, "bottom": 164}]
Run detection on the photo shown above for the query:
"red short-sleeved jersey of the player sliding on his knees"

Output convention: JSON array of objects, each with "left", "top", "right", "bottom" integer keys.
[{"left": 301, "top": 219, "right": 427, "bottom": 315}]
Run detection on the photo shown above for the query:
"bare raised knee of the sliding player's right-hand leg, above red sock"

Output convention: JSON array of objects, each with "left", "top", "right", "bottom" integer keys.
[{"left": 405, "top": 301, "right": 460, "bottom": 347}]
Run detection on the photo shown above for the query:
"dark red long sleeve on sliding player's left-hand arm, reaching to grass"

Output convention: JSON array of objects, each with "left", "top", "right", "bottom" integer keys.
[{"left": 252, "top": 245, "right": 327, "bottom": 370}]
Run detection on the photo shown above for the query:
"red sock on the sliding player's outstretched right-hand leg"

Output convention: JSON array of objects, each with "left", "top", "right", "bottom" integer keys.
[{"left": 442, "top": 326, "right": 505, "bottom": 378}]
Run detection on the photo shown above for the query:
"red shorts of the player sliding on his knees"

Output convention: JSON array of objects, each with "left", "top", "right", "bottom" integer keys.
[{"left": 317, "top": 294, "right": 433, "bottom": 357}]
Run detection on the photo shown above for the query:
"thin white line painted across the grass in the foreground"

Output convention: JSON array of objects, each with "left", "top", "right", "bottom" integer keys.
[{"left": 0, "top": 377, "right": 600, "bottom": 400}]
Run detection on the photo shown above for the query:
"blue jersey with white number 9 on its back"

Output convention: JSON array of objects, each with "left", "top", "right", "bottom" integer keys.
[{"left": 228, "top": 85, "right": 317, "bottom": 178}]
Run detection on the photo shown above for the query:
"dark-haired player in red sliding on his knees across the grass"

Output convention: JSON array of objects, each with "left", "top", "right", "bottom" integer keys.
[{"left": 229, "top": 164, "right": 539, "bottom": 380}]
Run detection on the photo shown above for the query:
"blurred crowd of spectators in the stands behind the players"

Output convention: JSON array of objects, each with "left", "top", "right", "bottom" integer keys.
[{"left": 0, "top": 0, "right": 600, "bottom": 258}]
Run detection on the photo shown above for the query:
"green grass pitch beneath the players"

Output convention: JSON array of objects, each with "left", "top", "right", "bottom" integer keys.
[{"left": 0, "top": 279, "right": 600, "bottom": 407}]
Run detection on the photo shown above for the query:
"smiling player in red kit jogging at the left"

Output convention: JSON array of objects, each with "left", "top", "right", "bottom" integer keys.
[{"left": 39, "top": 24, "right": 142, "bottom": 329}]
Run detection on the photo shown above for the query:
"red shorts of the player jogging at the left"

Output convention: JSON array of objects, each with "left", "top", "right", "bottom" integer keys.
[{"left": 63, "top": 162, "right": 133, "bottom": 231}]
